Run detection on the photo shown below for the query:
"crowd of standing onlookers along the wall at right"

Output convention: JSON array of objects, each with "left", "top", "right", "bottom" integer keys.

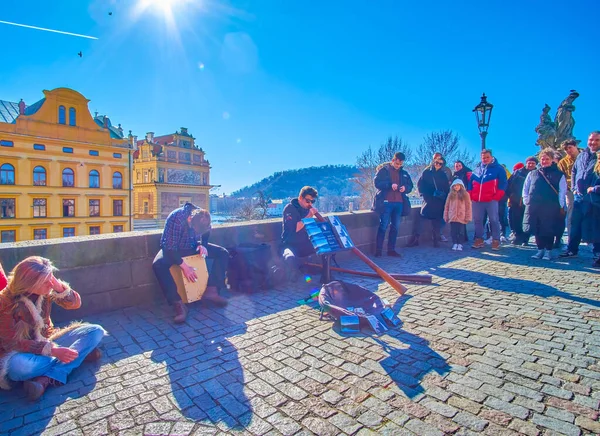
[{"left": 373, "top": 131, "right": 600, "bottom": 268}]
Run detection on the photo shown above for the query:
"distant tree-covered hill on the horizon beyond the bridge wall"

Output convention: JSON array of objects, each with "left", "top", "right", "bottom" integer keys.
[{"left": 232, "top": 165, "right": 359, "bottom": 198}]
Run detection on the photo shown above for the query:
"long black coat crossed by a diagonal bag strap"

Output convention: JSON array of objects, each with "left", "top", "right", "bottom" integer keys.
[{"left": 523, "top": 163, "right": 565, "bottom": 236}]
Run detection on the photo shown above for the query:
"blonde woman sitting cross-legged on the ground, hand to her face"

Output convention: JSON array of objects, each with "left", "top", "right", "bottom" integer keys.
[{"left": 0, "top": 256, "right": 106, "bottom": 400}]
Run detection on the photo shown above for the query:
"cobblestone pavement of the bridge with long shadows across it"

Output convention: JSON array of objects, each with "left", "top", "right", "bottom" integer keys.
[{"left": 0, "top": 242, "right": 600, "bottom": 435}]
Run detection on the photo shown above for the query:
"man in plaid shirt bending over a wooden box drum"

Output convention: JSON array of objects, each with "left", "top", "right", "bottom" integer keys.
[{"left": 152, "top": 203, "right": 229, "bottom": 323}]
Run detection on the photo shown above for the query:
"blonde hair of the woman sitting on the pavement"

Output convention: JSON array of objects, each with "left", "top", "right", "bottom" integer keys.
[{"left": 0, "top": 256, "right": 57, "bottom": 298}]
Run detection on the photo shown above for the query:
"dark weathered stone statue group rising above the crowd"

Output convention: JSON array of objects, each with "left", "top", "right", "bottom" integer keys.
[{"left": 535, "top": 89, "right": 579, "bottom": 150}]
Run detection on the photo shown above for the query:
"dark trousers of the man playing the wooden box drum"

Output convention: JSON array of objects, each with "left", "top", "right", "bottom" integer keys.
[{"left": 152, "top": 243, "right": 229, "bottom": 304}]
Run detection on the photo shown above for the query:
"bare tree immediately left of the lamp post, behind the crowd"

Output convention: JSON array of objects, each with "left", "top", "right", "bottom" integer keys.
[{"left": 412, "top": 130, "right": 475, "bottom": 168}]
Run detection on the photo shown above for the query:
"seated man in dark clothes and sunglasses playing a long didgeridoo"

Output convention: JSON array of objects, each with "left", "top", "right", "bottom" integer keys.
[{"left": 281, "top": 186, "right": 318, "bottom": 279}]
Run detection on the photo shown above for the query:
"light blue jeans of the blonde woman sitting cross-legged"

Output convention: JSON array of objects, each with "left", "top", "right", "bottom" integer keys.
[{"left": 8, "top": 324, "right": 106, "bottom": 383}]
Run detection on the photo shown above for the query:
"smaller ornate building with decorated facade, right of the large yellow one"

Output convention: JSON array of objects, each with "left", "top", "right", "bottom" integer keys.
[{"left": 133, "top": 127, "right": 212, "bottom": 221}]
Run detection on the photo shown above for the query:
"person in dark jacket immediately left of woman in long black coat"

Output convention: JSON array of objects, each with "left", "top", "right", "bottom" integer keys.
[{"left": 506, "top": 156, "right": 538, "bottom": 246}]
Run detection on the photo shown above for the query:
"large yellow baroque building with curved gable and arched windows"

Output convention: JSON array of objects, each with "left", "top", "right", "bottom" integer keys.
[{"left": 0, "top": 88, "right": 132, "bottom": 242}]
